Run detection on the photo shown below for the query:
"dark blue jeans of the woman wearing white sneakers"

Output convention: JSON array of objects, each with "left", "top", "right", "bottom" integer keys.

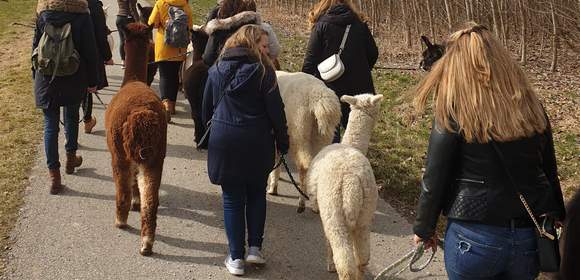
[{"left": 222, "top": 178, "right": 267, "bottom": 260}]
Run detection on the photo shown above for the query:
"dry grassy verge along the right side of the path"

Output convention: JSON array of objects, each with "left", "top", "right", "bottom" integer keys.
[{"left": 261, "top": 2, "right": 580, "bottom": 221}]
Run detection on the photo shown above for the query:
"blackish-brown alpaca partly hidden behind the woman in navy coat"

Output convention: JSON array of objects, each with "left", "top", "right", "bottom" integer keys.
[{"left": 182, "top": 28, "right": 209, "bottom": 148}]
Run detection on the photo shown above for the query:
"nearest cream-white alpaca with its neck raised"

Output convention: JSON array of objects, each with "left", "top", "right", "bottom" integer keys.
[{"left": 306, "top": 94, "right": 383, "bottom": 280}]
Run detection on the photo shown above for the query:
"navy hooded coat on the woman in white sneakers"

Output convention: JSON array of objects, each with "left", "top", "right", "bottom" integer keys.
[{"left": 202, "top": 48, "right": 289, "bottom": 186}]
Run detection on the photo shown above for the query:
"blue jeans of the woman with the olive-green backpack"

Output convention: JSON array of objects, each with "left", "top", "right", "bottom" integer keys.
[{"left": 42, "top": 104, "right": 80, "bottom": 169}]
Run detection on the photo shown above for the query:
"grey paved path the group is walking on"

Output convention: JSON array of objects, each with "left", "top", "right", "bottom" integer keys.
[{"left": 2, "top": 0, "right": 446, "bottom": 279}]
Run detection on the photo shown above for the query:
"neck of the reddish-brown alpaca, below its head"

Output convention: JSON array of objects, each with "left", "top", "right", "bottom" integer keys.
[{"left": 123, "top": 44, "right": 149, "bottom": 85}]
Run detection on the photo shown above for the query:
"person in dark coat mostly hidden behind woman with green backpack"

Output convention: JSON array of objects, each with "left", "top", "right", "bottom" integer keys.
[{"left": 82, "top": 0, "right": 114, "bottom": 133}]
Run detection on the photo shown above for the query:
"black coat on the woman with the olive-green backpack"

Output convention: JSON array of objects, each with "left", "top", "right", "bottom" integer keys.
[{"left": 32, "top": 11, "right": 98, "bottom": 109}]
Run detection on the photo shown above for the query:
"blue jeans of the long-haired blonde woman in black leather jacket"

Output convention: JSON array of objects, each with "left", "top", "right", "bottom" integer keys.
[{"left": 445, "top": 220, "right": 539, "bottom": 280}]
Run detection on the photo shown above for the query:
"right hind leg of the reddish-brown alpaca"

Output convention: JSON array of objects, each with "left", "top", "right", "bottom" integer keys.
[{"left": 139, "top": 161, "right": 163, "bottom": 256}]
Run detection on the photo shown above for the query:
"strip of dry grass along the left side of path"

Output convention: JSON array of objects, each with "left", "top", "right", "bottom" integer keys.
[{"left": 0, "top": 0, "right": 42, "bottom": 275}]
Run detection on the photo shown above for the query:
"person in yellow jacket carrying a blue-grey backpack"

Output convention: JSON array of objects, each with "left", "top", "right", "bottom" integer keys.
[{"left": 149, "top": 0, "right": 193, "bottom": 120}]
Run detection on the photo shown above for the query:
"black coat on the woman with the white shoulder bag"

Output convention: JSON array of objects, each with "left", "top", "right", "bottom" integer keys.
[{"left": 302, "top": 4, "right": 379, "bottom": 96}]
